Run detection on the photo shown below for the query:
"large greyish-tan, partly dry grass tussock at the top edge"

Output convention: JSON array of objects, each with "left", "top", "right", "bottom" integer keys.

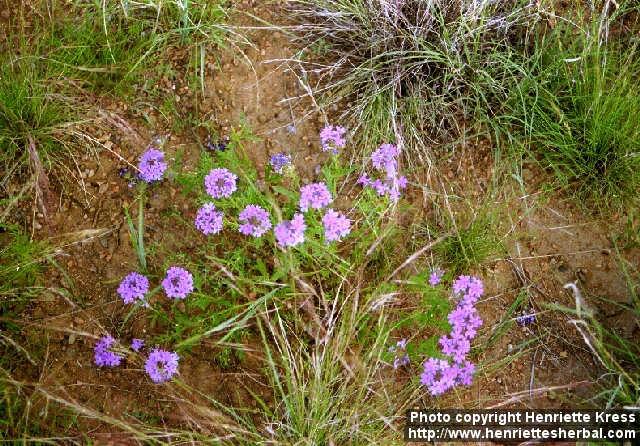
[{"left": 291, "top": 0, "right": 540, "bottom": 160}]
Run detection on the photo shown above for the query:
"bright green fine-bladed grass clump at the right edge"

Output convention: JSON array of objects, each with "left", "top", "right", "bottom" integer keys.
[{"left": 514, "top": 19, "right": 640, "bottom": 211}]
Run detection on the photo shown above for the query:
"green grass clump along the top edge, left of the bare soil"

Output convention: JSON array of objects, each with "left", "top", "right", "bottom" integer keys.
[{"left": 44, "top": 0, "right": 227, "bottom": 95}]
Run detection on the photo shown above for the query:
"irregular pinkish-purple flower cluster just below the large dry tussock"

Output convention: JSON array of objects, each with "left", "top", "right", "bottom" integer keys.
[{"left": 358, "top": 144, "right": 407, "bottom": 201}]
